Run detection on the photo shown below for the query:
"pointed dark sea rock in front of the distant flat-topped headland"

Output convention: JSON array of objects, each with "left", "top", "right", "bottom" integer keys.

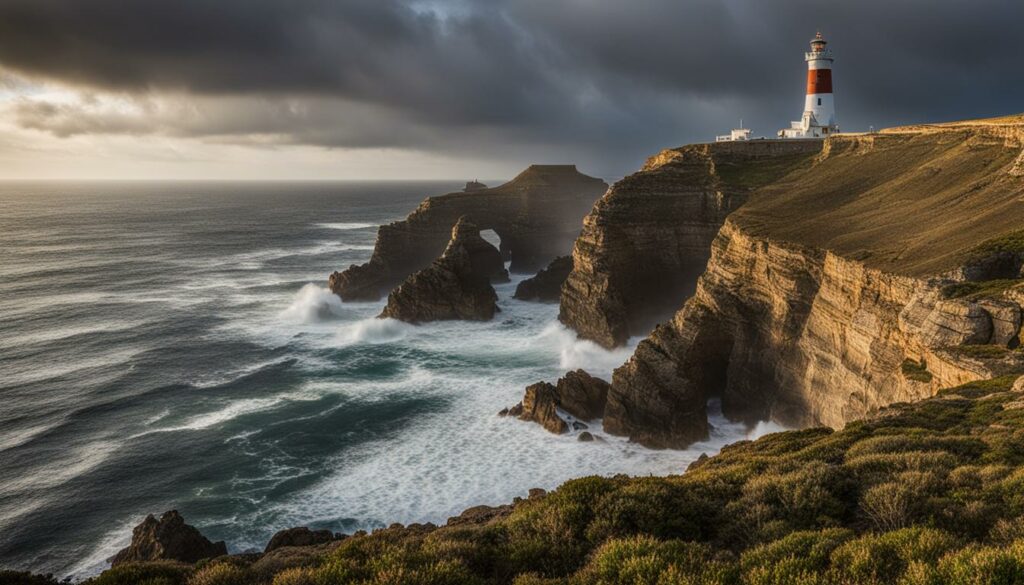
[{"left": 380, "top": 217, "right": 508, "bottom": 323}]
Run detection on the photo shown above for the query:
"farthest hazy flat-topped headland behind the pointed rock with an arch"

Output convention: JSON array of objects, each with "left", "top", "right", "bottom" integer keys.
[{"left": 329, "top": 165, "right": 608, "bottom": 301}]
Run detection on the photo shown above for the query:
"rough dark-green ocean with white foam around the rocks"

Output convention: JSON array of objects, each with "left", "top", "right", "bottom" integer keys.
[{"left": 0, "top": 181, "right": 776, "bottom": 578}]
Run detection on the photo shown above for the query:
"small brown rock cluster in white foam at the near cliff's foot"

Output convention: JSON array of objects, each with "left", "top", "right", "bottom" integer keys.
[{"left": 499, "top": 370, "right": 610, "bottom": 434}]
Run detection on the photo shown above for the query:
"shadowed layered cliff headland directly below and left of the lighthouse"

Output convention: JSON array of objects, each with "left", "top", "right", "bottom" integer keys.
[{"left": 559, "top": 140, "right": 821, "bottom": 347}]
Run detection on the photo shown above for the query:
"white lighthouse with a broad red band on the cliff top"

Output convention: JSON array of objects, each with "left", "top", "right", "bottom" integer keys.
[{"left": 778, "top": 33, "right": 839, "bottom": 138}]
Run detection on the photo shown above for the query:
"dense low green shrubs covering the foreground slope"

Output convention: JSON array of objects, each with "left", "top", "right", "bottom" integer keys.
[{"left": 81, "top": 378, "right": 1024, "bottom": 585}]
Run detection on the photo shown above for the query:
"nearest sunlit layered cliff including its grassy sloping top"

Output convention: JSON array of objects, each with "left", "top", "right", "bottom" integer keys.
[{"left": 598, "top": 120, "right": 1024, "bottom": 447}]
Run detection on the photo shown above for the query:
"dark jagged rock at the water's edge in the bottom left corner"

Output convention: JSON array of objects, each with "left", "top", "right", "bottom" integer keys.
[{"left": 111, "top": 510, "right": 227, "bottom": 567}]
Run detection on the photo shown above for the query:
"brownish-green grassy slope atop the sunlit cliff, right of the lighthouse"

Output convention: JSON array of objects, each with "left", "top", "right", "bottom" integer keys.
[{"left": 732, "top": 115, "right": 1024, "bottom": 277}]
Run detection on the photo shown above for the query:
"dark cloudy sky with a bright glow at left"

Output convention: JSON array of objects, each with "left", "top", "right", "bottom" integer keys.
[{"left": 0, "top": 0, "right": 1024, "bottom": 179}]
